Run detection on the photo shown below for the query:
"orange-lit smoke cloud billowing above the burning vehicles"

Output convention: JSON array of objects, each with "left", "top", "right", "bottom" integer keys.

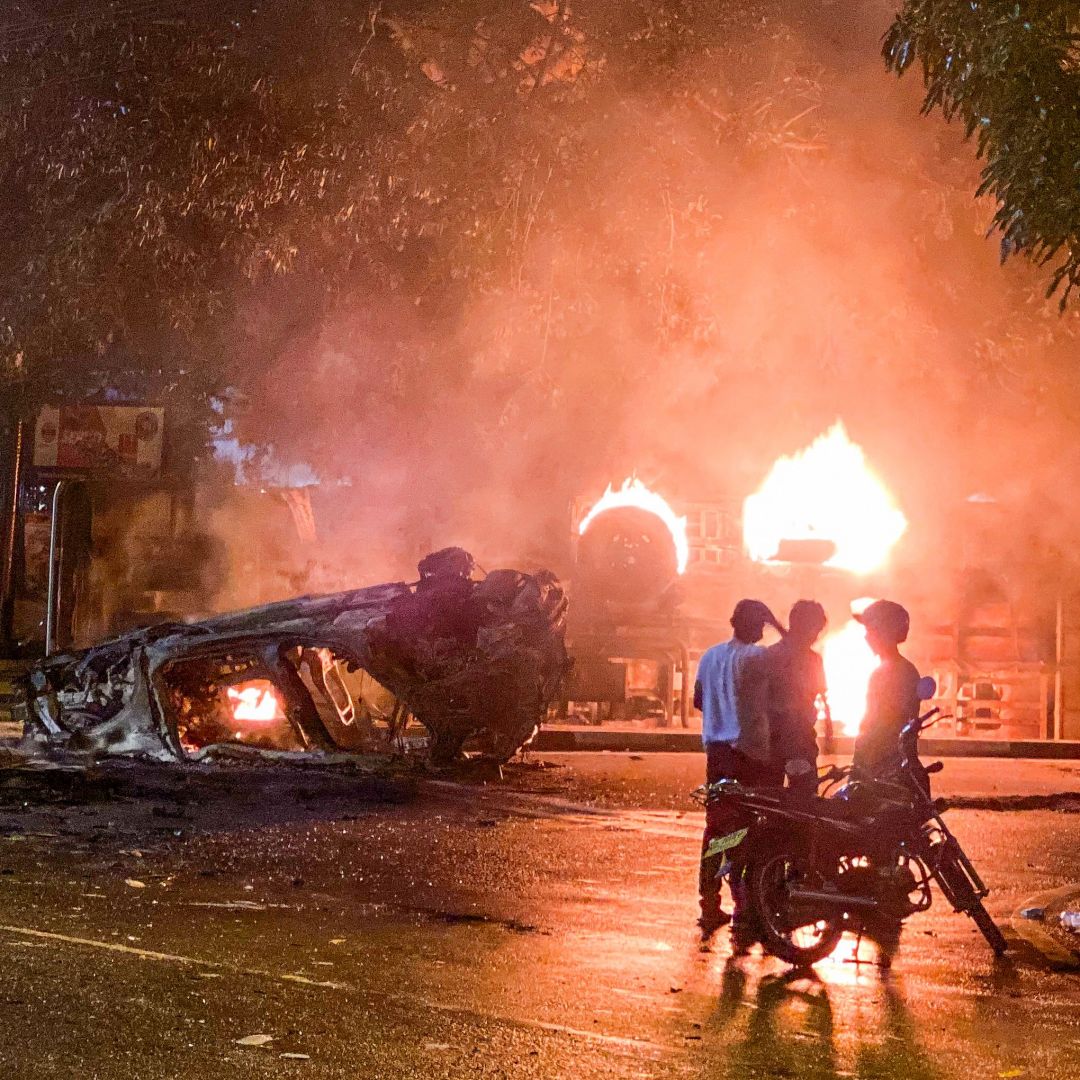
[{"left": 208, "top": 0, "right": 1080, "bottom": 626}]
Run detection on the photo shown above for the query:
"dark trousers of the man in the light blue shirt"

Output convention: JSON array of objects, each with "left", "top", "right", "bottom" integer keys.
[{"left": 698, "top": 743, "right": 784, "bottom": 923}]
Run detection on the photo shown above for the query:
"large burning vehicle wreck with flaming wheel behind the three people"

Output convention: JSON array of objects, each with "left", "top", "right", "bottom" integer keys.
[{"left": 566, "top": 421, "right": 1080, "bottom": 741}]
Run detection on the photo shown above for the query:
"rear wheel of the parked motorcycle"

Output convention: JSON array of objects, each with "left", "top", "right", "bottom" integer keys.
[{"left": 750, "top": 851, "right": 843, "bottom": 968}]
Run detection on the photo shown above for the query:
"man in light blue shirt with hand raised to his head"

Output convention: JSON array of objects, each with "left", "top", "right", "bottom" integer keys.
[{"left": 693, "top": 599, "right": 781, "bottom": 940}]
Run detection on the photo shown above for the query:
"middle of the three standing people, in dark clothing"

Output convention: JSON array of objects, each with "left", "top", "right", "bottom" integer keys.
[{"left": 766, "top": 600, "right": 833, "bottom": 795}]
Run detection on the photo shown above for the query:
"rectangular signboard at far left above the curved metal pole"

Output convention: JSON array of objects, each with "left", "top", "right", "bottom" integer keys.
[{"left": 33, "top": 405, "right": 165, "bottom": 480}]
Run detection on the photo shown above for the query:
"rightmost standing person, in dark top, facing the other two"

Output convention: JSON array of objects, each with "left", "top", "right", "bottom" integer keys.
[{"left": 852, "top": 600, "right": 919, "bottom": 777}]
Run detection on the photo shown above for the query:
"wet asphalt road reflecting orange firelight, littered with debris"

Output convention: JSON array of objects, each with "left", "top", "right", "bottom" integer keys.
[{"left": 0, "top": 755, "right": 1080, "bottom": 1080}]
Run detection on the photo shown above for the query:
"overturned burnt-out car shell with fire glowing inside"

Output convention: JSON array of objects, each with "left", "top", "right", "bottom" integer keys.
[{"left": 26, "top": 548, "right": 568, "bottom": 761}]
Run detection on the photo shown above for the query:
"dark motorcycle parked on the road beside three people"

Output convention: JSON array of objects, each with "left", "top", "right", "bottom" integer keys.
[{"left": 696, "top": 677, "right": 1008, "bottom": 968}]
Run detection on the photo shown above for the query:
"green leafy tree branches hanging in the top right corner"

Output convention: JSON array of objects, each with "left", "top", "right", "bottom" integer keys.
[{"left": 883, "top": 0, "right": 1080, "bottom": 308}]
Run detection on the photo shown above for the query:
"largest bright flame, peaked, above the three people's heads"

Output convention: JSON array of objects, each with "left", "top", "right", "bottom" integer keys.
[{"left": 743, "top": 420, "right": 907, "bottom": 573}]
